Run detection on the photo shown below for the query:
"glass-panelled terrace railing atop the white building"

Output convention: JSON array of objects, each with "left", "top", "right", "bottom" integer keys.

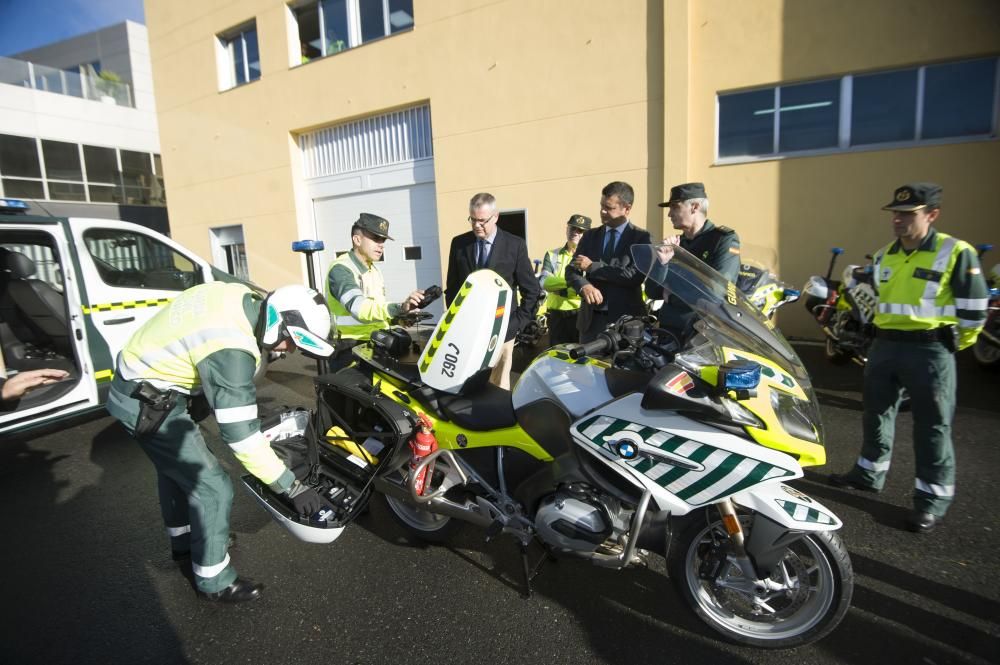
[{"left": 0, "top": 57, "right": 135, "bottom": 107}]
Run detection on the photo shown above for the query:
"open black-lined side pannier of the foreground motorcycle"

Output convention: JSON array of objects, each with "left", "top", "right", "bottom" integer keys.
[{"left": 243, "top": 370, "right": 417, "bottom": 543}]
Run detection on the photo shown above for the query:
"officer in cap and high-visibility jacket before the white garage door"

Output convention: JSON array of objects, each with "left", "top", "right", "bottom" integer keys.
[{"left": 326, "top": 212, "right": 424, "bottom": 371}]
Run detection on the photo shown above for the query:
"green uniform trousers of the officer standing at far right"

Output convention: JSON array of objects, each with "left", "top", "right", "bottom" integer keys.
[{"left": 850, "top": 339, "right": 956, "bottom": 517}]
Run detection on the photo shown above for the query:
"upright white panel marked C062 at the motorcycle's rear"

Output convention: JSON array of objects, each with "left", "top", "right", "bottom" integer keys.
[{"left": 417, "top": 270, "right": 513, "bottom": 394}]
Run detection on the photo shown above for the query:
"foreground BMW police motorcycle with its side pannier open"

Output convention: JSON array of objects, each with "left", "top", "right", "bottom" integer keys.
[{"left": 244, "top": 245, "right": 854, "bottom": 648}]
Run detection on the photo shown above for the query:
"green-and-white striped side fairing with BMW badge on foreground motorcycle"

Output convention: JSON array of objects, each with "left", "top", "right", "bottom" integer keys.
[{"left": 571, "top": 394, "right": 802, "bottom": 514}]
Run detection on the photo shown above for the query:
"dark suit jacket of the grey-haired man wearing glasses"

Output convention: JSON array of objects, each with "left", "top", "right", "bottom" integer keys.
[{"left": 444, "top": 229, "right": 542, "bottom": 341}]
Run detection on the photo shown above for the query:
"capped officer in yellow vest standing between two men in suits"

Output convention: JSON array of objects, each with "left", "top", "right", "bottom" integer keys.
[{"left": 538, "top": 215, "right": 592, "bottom": 345}]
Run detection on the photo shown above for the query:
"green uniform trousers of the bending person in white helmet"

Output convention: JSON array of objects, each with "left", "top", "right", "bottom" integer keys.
[{"left": 107, "top": 375, "right": 236, "bottom": 593}]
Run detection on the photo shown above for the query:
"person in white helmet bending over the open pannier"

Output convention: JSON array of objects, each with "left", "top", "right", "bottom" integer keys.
[{"left": 107, "top": 282, "right": 333, "bottom": 603}]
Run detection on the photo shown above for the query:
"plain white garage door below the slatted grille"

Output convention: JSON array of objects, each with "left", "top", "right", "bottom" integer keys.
[{"left": 313, "top": 182, "right": 443, "bottom": 315}]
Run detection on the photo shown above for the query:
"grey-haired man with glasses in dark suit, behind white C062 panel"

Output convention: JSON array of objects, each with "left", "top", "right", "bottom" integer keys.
[{"left": 444, "top": 192, "right": 542, "bottom": 390}]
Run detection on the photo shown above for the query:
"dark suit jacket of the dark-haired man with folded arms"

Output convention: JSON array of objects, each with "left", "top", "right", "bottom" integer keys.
[{"left": 566, "top": 222, "right": 653, "bottom": 332}]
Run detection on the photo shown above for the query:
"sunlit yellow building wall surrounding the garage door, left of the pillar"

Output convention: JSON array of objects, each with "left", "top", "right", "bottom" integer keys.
[{"left": 146, "top": 0, "right": 663, "bottom": 287}]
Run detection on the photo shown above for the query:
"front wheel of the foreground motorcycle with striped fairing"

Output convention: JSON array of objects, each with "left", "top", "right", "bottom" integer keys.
[{"left": 672, "top": 515, "right": 854, "bottom": 649}]
